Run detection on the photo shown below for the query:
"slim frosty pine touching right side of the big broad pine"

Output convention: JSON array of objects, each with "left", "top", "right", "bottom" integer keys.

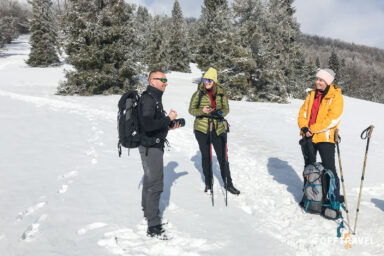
[{"left": 135, "top": 5, "right": 153, "bottom": 65}]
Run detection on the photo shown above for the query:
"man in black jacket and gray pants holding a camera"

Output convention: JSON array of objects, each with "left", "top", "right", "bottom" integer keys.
[{"left": 139, "top": 71, "right": 180, "bottom": 237}]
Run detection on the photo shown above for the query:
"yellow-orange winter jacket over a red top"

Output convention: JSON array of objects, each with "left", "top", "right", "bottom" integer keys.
[{"left": 298, "top": 84, "right": 344, "bottom": 143}]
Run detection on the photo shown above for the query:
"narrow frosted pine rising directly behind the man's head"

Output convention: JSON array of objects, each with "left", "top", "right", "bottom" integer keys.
[{"left": 148, "top": 15, "right": 170, "bottom": 71}]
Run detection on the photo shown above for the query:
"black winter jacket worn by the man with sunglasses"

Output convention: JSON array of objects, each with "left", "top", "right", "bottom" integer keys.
[{"left": 139, "top": 85, "right": 171, "bottom": 149}]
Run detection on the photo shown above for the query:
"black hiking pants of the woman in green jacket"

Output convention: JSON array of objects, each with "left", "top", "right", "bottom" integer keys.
[{"left": 195, "top": 130, "right": 233, "bottom": 186}]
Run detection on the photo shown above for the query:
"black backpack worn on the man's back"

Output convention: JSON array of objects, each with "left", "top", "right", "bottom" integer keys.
[{"left": 117, "top": 91, "right": 140, "bottom": 157}]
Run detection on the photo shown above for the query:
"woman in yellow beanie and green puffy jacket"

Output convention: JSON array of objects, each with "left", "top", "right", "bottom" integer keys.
[{"left": 189, "top": 67, "right": 240, "bottom": 195}]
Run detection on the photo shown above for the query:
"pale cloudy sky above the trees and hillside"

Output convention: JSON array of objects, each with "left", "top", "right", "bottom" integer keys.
[{"left": 126, "top": 0, "right": 384, "bottom": 49}]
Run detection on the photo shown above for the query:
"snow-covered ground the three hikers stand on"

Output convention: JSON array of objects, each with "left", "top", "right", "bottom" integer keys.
[{"left": 0, "top": 36, "right": 384, "bottom": 256}]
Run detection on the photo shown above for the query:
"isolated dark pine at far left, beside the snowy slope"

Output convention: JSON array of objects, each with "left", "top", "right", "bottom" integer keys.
[{"left": 27, "top": 0, "right": 60, "bottom": 67}]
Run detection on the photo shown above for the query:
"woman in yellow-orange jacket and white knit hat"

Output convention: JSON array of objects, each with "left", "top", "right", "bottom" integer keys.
[{"left": 298, "top": 69, "right": 344, "bottom": 200}]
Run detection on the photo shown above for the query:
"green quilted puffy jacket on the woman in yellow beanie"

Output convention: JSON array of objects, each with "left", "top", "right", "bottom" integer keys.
[{"left": 189, "top": 83, "right": 229, "bottom": 135}]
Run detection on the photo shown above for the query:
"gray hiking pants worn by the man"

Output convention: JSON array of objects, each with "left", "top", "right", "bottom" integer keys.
[{"left": 139, "top": 146, "right": 164, "bottom": 227}]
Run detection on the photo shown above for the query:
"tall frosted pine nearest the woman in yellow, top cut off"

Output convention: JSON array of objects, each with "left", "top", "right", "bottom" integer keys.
[{"left": 250, "top": 0, "right": 302, "bottom": 103}]
